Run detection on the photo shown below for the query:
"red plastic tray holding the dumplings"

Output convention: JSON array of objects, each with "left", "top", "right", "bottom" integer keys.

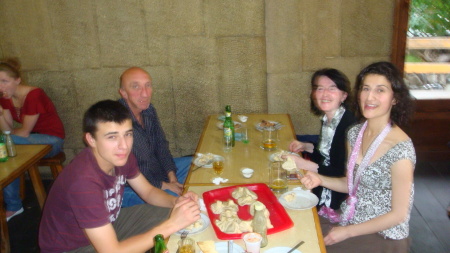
[{"left": 203, "top": 183, "right": 294, "bottom": 240}]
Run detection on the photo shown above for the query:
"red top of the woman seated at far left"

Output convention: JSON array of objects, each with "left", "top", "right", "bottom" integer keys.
[{"left": 0, "top": 88, "right": 65, "bottom": 139}]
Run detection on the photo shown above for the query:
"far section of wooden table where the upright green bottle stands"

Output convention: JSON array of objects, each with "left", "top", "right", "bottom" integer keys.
[{"left": 185, "top": 114, "right": 298, "bottom": 185}]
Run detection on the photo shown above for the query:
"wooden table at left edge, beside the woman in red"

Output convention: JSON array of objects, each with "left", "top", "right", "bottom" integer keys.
[{"left": 0, "top": 145, "right": 52, "bottom": 253}]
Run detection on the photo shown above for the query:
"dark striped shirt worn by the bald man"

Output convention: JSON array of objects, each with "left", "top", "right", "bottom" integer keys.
[{"left": 119, "top": 98, "right": 177, "bottom": 188}]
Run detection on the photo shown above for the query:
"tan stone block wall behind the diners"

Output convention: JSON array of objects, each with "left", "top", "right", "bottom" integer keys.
[{"left": 0, "top": 0, "right": 394, "bottom": 162}]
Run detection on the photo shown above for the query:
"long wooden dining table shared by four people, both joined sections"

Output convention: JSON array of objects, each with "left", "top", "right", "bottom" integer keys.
[{"left": 167, "top": 114, "right": 326, "bottom": 253}]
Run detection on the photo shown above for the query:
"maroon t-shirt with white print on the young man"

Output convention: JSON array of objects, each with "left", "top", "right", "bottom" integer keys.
[{"left": 39, "top": 148, "right": 140, "bottom": 252}]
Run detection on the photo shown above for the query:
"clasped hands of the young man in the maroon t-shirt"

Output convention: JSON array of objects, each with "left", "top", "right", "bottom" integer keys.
[{"left": 169, "top": 196, "right": 200, "bottom": 230}]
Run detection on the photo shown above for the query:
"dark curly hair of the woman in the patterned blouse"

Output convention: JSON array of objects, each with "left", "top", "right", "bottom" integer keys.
[{"left": 354, "top": 62, "right": 414, "bottom": 126}]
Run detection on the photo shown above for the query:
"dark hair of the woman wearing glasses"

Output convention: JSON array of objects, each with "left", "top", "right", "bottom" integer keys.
[{"left": 310, "top": 68, "right": 351, "bottom": 115}]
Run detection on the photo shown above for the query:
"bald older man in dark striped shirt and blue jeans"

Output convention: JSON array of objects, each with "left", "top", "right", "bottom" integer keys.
[{"left": 119, "top": 67, "right": 192, "bottom": 207}]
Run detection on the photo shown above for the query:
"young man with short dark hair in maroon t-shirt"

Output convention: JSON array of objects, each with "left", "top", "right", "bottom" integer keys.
[{"left": 39, "top": 100, "right": 200, "bottom": 253}]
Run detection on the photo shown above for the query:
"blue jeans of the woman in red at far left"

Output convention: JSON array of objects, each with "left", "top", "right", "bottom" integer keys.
[{"left": 3, "top": 134, "right": 64, "bottom": 212}]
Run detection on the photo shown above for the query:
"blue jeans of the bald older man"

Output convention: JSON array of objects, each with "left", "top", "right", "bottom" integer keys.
[{"left": 122, "top": 156, "right": 192, "bottom": 208}]
